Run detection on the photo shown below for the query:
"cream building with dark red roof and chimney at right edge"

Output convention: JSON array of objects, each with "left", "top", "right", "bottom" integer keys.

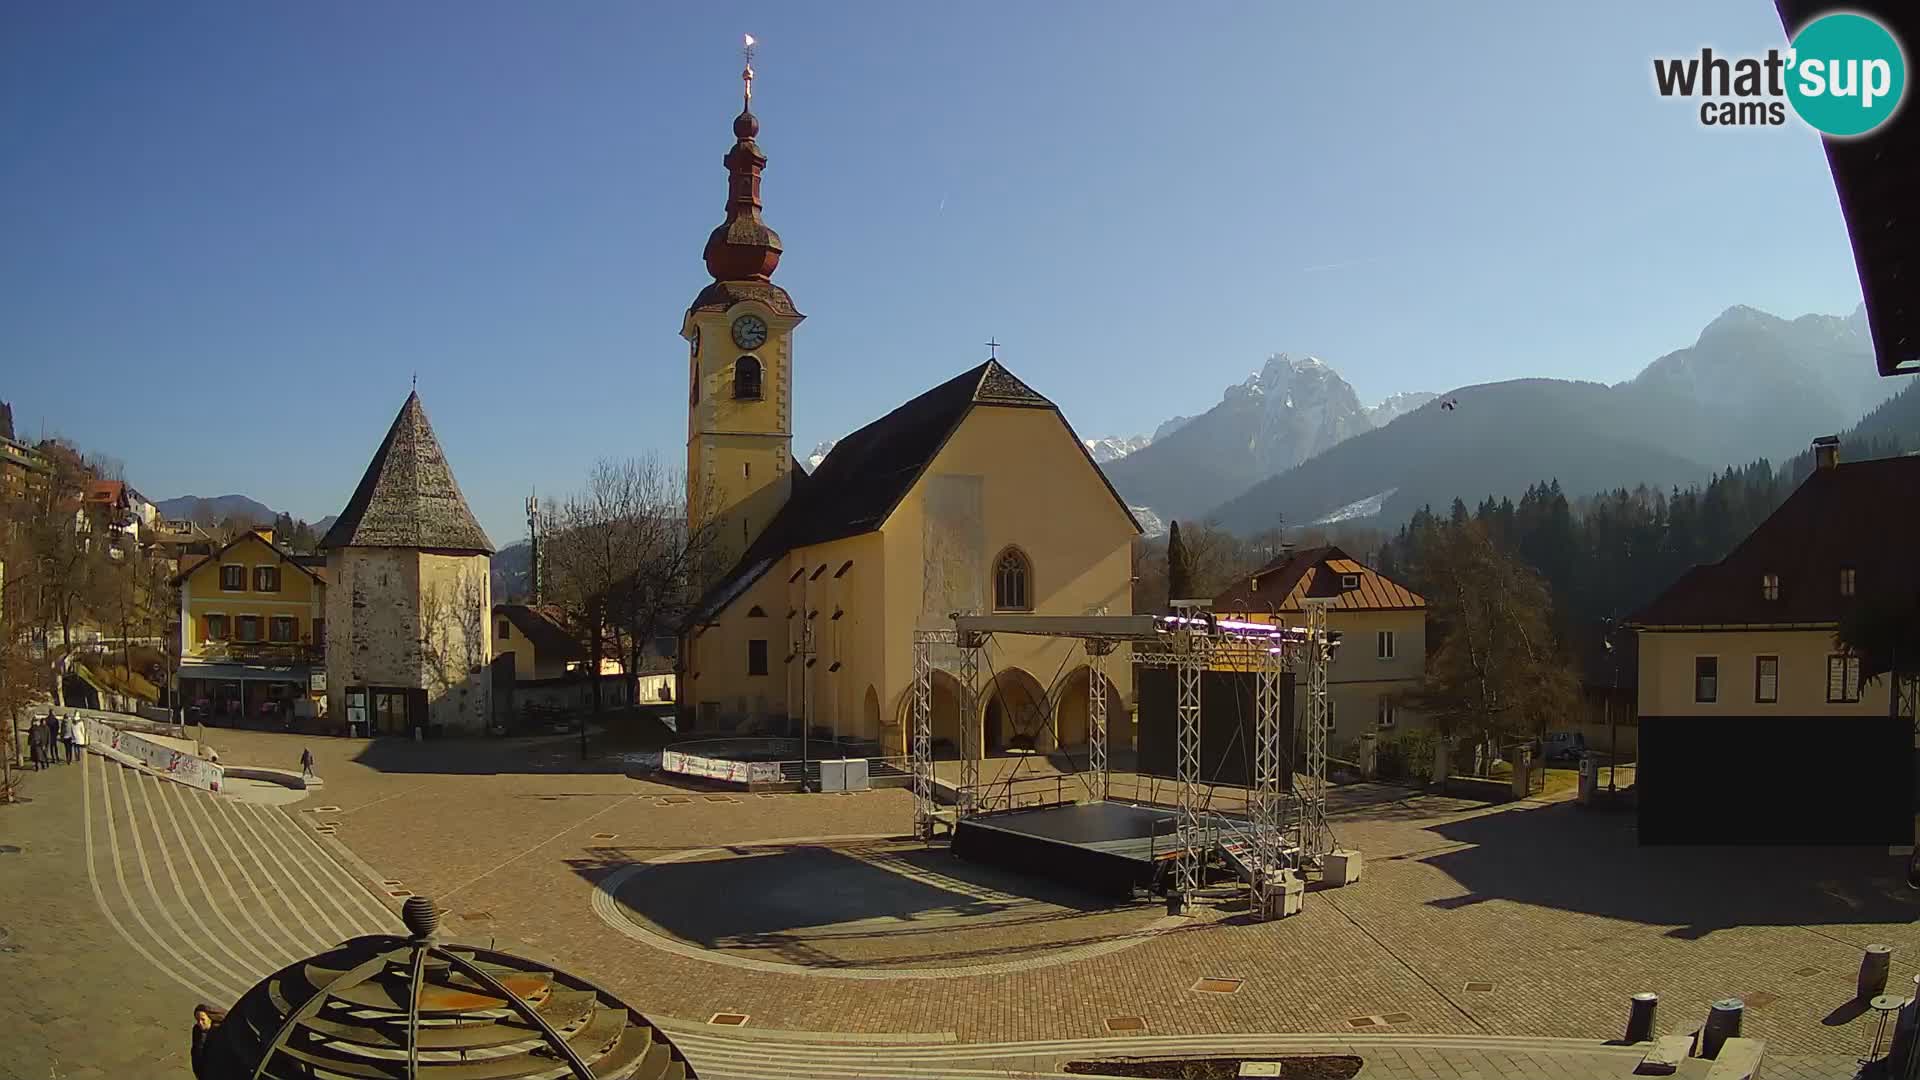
[{"left": 1632, "top": 436, "right": 1920, "bottom": 844}]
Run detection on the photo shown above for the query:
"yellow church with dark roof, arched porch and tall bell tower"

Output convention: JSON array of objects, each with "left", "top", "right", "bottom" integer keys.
[{"left": 678, "top": 52, "right": 1140, "bottom": 755}]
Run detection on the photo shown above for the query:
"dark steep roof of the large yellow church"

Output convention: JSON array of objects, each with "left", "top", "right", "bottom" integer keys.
[{"left": 691, "top": 359, "right": 1139, "bottom": 623}]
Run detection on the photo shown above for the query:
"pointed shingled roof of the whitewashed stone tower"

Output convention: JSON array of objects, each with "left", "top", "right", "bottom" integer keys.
[{"left": 321, "top": 392, "right": 493, "bottom": 555}]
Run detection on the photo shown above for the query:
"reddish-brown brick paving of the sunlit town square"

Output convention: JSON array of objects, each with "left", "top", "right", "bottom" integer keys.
[{"left": 0, "top": 718, "right": 1920, "bottom": 1080}]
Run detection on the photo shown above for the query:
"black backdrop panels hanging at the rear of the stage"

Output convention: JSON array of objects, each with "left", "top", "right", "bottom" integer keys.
[{"left": 1139, "top": 667, "right": 1296, "bottom": 792}]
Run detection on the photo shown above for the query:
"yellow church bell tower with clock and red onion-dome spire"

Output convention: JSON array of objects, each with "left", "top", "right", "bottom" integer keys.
[{"left": 680, "top": 37, "right": 804, "bottom": 575}]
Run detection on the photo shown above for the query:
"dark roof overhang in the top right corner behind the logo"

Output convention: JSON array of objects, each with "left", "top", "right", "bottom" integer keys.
[{"left": 1774, "top": 0, "right": 1920, "bottom": 375}]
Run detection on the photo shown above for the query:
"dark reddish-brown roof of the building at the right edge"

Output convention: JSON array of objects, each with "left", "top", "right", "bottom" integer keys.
[{"left": 1632, "top": 457, "right": 1920, "bottom": 626}]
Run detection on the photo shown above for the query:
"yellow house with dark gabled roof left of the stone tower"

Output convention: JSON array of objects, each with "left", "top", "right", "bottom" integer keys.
[{"left": 173, "top": 528, "right": 326, "bottom": 723}]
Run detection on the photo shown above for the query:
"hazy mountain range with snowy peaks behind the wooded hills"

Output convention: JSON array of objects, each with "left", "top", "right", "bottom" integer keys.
[{"left": 1104, "top": 297, "right": 1893, "bottom": 532}]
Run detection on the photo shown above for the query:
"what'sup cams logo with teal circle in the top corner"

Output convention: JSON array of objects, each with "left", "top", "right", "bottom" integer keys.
[{"left": 1653, "top": 12, "right": 1907, "bottom": 138}]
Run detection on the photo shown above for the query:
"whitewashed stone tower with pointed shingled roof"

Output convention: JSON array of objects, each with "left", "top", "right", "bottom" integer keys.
[{"left": 321, "top": 394, "right": 493, "bottom": 734}]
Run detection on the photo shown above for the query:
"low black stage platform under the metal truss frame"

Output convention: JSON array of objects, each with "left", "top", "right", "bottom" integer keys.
[{"left": 952, "top": 801, "right": 1244, "bottom": 899}]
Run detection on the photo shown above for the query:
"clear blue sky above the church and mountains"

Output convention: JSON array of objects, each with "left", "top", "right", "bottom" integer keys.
[{"left": 0, "top": 0, "right": 1859, "bottom": 544}]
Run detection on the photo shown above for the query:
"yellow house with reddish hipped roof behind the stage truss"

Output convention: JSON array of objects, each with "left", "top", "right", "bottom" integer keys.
[{"left": 1213, "top": 544, "right": 1427, "bottom": 753}]
